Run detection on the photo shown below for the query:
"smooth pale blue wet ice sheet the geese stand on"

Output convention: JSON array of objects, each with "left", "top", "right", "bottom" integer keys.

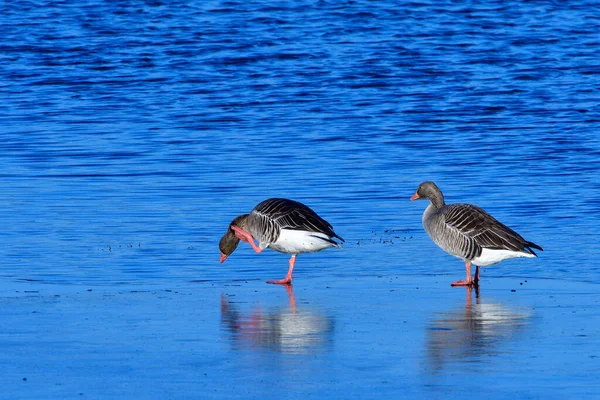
[{"left": 0, "top": 276, "right": 600, "bottom": 399}]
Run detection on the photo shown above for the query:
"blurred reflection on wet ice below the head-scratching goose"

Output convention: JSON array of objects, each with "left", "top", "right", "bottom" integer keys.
[{"left": 221, "top": 285, "right": 334, "bottom": 353}]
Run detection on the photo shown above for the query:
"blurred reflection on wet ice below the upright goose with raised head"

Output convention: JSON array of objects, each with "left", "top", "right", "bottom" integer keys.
[{"left": 426, "top": 287, "right": 532, "bottom": 374}]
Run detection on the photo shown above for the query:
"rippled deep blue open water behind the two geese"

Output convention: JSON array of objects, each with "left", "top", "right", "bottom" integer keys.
[{"left": 0, "top": 0, "right": 600, "bottom": 397}]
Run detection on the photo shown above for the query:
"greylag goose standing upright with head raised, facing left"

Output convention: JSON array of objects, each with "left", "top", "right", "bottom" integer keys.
[{"left": 410, "top": 182, "right": 543, "bottom": 286}]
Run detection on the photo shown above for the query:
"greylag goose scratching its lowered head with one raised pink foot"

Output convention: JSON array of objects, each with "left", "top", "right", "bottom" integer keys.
[{"left": 219, "top": 199, "right": 344, "bottom": 284}]
